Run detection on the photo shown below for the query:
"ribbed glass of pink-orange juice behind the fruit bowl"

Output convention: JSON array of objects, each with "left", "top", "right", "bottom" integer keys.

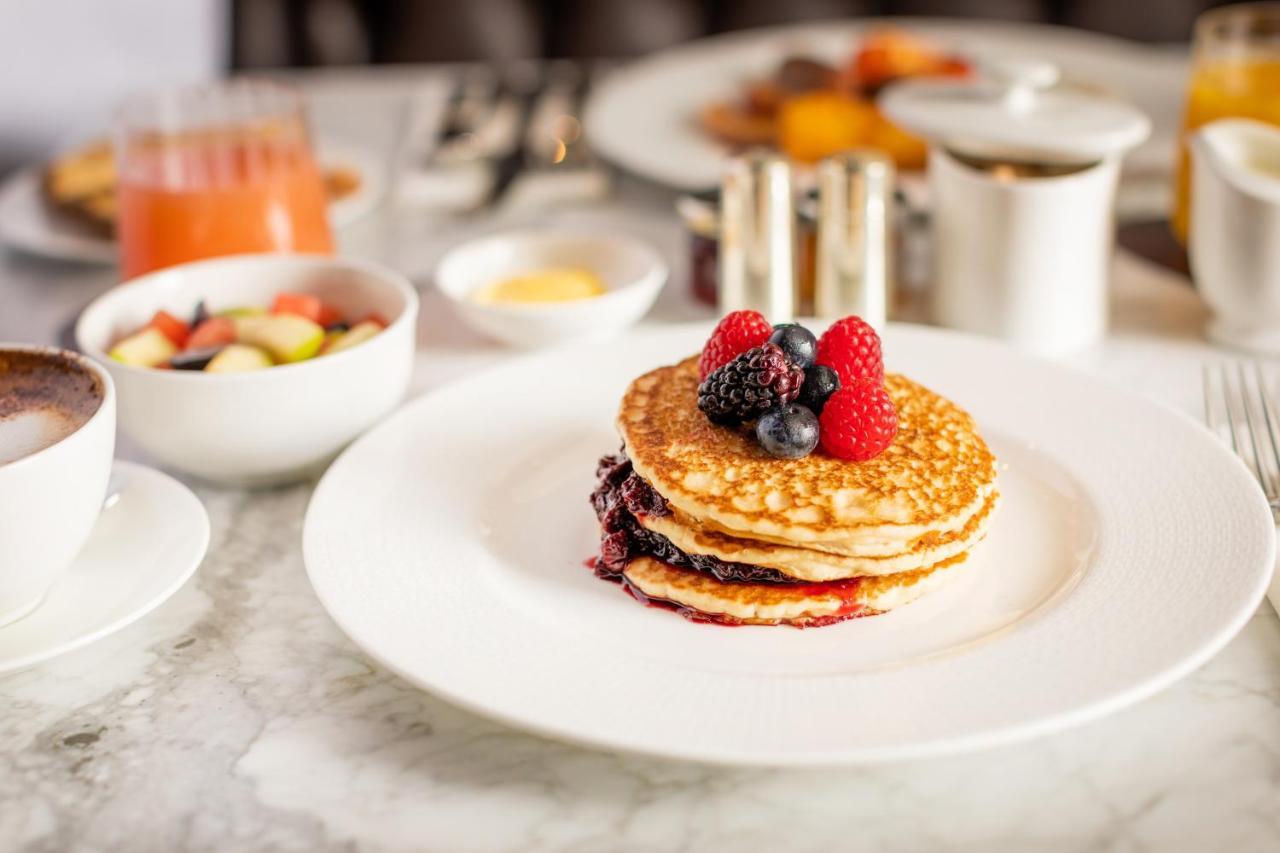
[{"left": 115, "top": 79, "right": 333, "bottom": 279}]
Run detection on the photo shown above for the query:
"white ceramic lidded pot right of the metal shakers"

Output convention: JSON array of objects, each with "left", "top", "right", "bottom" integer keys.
[{"left": 881, "top": 60, "right": 1151, "bottom": 356}]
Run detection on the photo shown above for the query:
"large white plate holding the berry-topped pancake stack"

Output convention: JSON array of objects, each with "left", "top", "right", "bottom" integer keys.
[{"left": 303, "top": 327, "right": 1275, "bottom": 765}]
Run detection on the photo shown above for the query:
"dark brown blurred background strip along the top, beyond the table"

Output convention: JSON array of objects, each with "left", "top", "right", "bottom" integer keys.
[{"left": 232, "top": 0, "right": 1220, "bottom": 68}]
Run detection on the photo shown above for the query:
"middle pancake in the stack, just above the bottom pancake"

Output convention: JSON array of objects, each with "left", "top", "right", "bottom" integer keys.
[{"left": 636, "top": 492, "right": 1000, "bottom": 583}]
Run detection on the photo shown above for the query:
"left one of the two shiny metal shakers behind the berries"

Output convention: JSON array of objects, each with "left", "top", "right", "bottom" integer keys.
[{"left": 719, "top": 152, "right": 796, "bottom": 323}]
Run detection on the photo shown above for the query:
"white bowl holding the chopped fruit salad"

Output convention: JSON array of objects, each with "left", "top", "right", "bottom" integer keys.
[{"left": 76, "top": 255, "right": 417, "bottom": 485}]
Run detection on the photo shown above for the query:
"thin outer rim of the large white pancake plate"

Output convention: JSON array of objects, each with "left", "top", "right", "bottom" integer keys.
[{"left": 302, "top": 323, "right": 1276, "bottom": 767}]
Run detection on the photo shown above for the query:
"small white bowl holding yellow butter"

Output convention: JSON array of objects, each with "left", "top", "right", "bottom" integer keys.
[{"left": 435, "top": 231, "right": 668, "bottom": 347}]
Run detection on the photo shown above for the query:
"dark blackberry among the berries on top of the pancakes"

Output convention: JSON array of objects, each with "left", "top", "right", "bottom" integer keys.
[{"left": 698, "top": 343, "right": 804, "bottom": 427}]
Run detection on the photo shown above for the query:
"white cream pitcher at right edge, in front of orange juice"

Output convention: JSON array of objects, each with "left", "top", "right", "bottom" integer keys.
[{"left": 1189, "top": 119, "right": 1280, "bottom": 355}]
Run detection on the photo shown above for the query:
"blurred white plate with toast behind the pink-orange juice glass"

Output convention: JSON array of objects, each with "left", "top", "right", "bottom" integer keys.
[{"left": 0, "top": 140, "right": 387, "bottom": 265}]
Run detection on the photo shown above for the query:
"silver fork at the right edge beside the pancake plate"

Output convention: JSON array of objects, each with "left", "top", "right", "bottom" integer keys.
[{"left": 1203, "top": 361, "right": 1280, "bottom": 613}]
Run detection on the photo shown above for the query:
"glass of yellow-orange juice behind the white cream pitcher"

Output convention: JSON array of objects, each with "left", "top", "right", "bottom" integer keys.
[{"left": 1172, "top": 3, "right": 1280, "bottom": 246}]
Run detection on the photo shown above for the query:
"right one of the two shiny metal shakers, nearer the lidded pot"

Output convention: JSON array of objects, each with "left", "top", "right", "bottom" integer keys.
[{"left": 814, "top": 151, "right": 893, "bottom": 329}]
